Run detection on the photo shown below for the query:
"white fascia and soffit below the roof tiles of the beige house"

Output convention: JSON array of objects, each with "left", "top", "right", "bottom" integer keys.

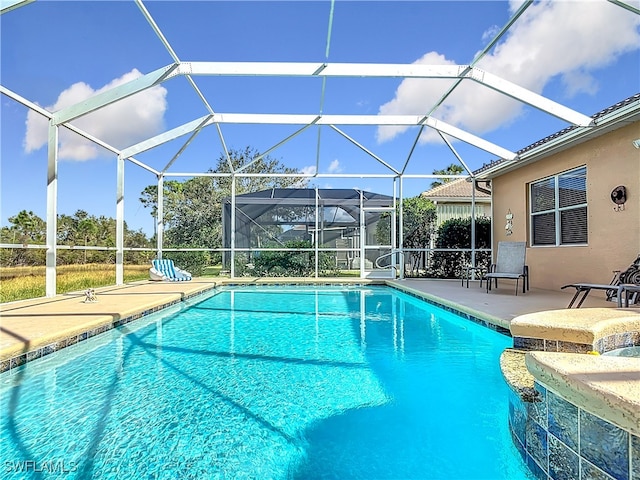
[{"left": 474, "top": 100, "right": 640, "bottom": 180}]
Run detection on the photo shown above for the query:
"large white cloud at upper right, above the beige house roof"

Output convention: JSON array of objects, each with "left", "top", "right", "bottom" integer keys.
[{"left": 377, "top": 0, "right": 640, "bottom": 142}]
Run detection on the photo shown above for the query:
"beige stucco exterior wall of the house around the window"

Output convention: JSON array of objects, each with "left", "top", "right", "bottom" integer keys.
[{"left": 492, "top": 122, "right": 640, "bottom": 290}]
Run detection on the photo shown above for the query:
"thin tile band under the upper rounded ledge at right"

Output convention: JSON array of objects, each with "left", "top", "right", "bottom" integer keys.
[{"left": 513, "top": 332, "right": 640, "bottom": 353}]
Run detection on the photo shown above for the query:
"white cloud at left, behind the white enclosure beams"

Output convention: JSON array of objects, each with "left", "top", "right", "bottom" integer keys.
[{"left": 24, "top": 69, "right": 167, "bottom": 161}]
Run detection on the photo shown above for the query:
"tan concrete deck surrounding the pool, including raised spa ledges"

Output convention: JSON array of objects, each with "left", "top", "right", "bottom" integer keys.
[{"left": 0, "top": 277, "right": 640, "bottom": 435}]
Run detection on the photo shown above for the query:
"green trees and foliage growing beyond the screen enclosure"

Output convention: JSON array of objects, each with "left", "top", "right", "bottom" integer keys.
[{"left": 0, "top": 147, "right": 476, "bottom": 276}]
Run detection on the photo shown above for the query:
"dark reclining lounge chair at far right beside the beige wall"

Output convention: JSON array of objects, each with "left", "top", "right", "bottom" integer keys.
[{"left": 560, "top": 255, "right": 640, "bottom": 308}]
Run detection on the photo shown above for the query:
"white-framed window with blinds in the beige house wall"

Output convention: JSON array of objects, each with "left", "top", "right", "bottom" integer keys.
[{"left": 529, "top": 167, "right": 588, "bottom": 246}]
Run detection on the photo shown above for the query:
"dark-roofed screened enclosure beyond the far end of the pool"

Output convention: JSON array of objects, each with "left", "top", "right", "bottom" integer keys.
[{"left": 222, "top": 188, "right": 403, "bottom": 278}]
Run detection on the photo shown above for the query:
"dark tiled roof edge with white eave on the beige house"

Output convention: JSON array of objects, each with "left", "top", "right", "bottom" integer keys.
[{"left": 473, "top": 93, "right": 640, "bottom": 179}]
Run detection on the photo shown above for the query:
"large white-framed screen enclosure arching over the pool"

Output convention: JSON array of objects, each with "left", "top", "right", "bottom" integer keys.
[{"left": 0, "top": 0, "right": 639, "bottom": 296}]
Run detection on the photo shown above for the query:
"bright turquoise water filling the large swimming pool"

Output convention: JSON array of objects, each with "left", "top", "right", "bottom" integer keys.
[{"left": 0, "top": 286, "right": 530, "bottom": 480}]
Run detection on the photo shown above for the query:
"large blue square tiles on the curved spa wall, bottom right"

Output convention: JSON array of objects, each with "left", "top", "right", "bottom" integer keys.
[{"left": 509, "top": 382, "right": 640, "bottom": 480}]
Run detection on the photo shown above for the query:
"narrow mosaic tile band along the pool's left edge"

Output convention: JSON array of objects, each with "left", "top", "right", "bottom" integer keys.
[{"left": 0, "top": 287, "right": 216, "bottom": 373}]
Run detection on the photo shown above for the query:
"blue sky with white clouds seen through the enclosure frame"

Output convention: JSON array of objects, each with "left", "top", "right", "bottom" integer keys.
[{"left": 0, "top": 0, "right": 640, "bottom": 233}]
